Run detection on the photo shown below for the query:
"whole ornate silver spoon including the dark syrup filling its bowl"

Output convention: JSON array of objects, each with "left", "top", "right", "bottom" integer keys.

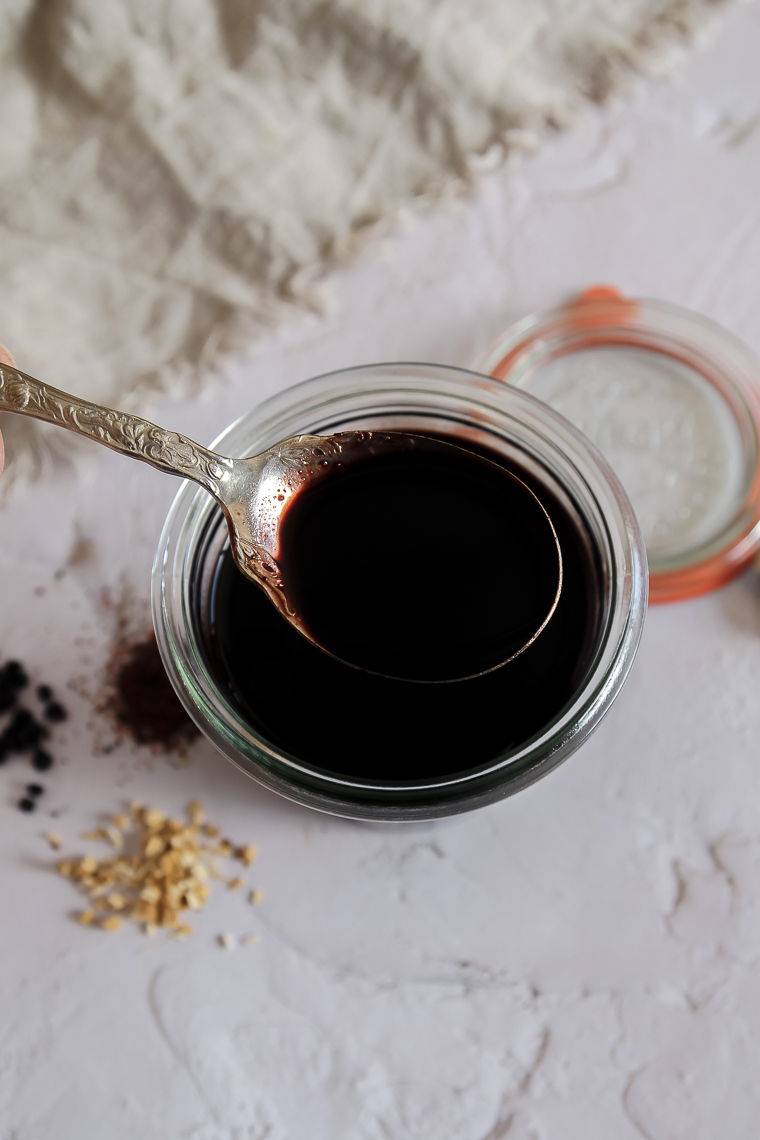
[{"left": 0, "top": 364, "right": 562, "bottom": 683}]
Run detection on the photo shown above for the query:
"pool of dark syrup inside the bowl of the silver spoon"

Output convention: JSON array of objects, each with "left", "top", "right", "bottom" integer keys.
[{"left": 273, "top": 432, "right": 562, "bottom": 683}]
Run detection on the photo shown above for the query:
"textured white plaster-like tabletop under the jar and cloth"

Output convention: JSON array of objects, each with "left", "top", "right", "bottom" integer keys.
[{"left": 0, "top": 6, "right": 760, "bottom": 1140}]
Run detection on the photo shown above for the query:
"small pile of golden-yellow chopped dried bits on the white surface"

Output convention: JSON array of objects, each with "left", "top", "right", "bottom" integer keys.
[{"left": 55, "top": 800, "right": 256, "bottom": 938}]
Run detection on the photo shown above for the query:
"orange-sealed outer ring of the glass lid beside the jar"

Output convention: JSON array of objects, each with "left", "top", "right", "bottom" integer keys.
[{"left": 475, "top": 285, "right": 760, "bottom": 603}]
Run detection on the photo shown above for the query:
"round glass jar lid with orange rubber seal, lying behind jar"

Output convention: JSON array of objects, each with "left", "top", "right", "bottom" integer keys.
[{"left": 475, "top": 285, "right": 760, "bottom": 602}]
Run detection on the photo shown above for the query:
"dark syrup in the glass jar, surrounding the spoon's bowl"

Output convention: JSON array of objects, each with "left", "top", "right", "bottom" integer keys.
[{"left": 207, "top": 437, "right": 600, "bottom": 782}]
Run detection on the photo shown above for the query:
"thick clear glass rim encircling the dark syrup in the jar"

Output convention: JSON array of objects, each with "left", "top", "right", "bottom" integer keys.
[{"left": 153, "top": 363, "right": 647, "bottom": 820}]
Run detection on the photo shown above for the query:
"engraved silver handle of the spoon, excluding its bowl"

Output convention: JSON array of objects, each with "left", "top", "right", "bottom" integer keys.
[{"left": 0, "top": 364, "right": 232, "bottom": 498}]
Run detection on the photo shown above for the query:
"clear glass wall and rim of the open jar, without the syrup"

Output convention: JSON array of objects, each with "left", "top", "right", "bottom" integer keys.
[{"left": 153, "top": 364, "right": 647, "bottom": 821}]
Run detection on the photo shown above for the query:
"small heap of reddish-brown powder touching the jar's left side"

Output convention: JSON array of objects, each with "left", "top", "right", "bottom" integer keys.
[{"left": 109, "top": 630, "right": 199, "bottom": 752}]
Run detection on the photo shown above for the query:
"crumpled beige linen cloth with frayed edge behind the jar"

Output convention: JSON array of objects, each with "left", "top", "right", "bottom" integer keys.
[{"left": 0, "top": 0, "right": 718, "bottom": 489}]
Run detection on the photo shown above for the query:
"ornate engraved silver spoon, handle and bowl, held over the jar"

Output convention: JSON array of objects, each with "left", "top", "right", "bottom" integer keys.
[{"left": 0, "top": 363, "right": 562, "bottom": 682}]
